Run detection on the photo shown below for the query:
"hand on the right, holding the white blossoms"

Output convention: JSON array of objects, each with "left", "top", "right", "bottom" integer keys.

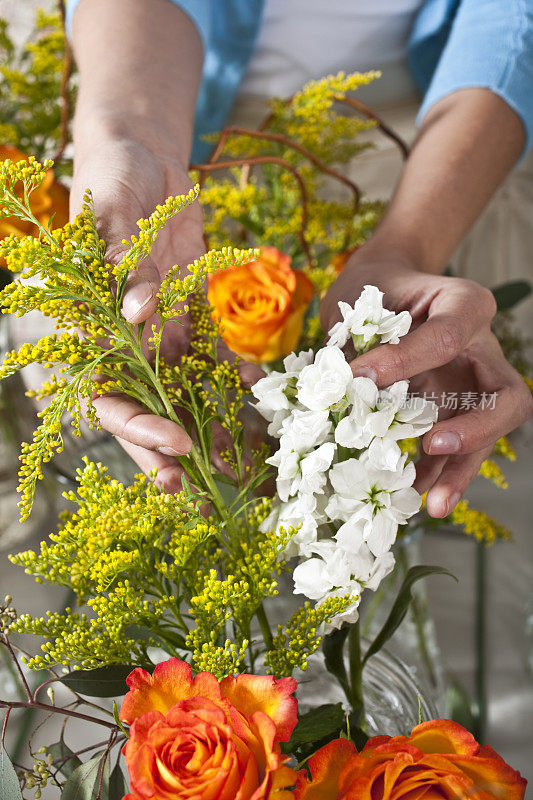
[{"left": 321, "top": 256, "right": 533, "bottom": 517}]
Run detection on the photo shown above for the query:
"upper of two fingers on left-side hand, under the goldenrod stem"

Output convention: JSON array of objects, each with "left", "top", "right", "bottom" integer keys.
[{"left": 93, "top": 395, "right": 192, "bottom": 457}]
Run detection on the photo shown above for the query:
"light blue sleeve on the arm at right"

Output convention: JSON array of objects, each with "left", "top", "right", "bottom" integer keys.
[{"left": 418, "top": 0, "right": 533, "bottom": 152}]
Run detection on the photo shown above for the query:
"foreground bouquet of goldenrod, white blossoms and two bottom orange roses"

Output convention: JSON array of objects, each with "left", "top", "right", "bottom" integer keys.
[{"left": 0, "top": 152, "right": 525, "bottom": 800}]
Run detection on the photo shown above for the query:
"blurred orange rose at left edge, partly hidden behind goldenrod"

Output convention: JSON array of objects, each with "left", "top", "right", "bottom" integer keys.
[{"left": 0, "top": 145, "right": 69, "bottom": 239}]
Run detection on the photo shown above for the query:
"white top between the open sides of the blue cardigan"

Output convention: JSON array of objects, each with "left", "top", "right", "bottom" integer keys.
[{"left": 240, "top": 0, "right": 424, "bottom": 104}]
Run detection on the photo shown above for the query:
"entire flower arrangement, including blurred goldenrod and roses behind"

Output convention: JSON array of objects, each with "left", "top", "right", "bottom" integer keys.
[{"left": 0, "top": 16, "right": 525, "bottom": 800}]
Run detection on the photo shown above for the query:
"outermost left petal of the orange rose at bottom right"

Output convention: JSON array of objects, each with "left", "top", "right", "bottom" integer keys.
[{"left": 294, "top": 739, "right": 357, "bottom": 800}]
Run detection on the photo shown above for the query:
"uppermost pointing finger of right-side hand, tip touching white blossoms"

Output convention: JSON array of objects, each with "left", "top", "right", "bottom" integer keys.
[{"left": 350, "top": 281, "right": 494, "bottom": 386}]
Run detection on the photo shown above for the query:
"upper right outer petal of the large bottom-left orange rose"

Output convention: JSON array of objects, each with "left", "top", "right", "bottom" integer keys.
[{"left": 220, "top": 675, "right": 298, "bottom": 742}]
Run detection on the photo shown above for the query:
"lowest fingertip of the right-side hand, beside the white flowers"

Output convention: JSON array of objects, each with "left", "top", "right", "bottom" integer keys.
[{"left": 426, "top": 446, "right": 492, "bottom": 519}]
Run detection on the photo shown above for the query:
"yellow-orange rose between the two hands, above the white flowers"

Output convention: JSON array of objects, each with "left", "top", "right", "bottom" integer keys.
[{"left": 208, "top": 247, "right": 313, "bottom": 361}]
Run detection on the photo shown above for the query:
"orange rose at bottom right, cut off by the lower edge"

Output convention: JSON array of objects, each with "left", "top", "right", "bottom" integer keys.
[{"left": 294, "top": 719, "right": 527, "bottom": 800}]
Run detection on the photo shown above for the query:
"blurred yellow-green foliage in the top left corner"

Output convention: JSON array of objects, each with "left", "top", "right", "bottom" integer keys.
[{"left": 0, "top": 9, "right": 75, "bottom": 168}]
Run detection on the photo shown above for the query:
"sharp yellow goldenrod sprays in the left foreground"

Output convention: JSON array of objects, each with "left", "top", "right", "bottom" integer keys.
[{"left": 0, "top": 159, "right": 336, "bottom": 677}]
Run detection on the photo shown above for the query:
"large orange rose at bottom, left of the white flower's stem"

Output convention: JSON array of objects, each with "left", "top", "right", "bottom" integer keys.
[{"left": 120, "top": 658, "right": 297, "bottom": 800}]
